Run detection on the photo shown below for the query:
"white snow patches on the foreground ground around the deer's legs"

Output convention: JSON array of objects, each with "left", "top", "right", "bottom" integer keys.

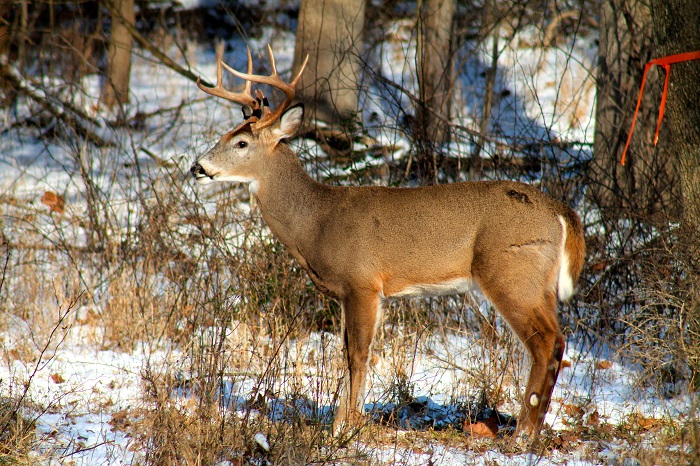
[{"left": 0, "top": 326, "right": 692, "bottom": 465}]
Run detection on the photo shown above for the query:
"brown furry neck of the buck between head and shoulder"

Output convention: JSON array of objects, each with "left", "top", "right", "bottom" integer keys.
[{"left": 255, "top": 146, "right": 332, "bottom": 252}]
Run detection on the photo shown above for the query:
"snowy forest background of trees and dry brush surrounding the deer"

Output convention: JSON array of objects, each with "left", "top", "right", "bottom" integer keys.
[{"left": 0, "top": 0, "right": 700, "bottom": 464}]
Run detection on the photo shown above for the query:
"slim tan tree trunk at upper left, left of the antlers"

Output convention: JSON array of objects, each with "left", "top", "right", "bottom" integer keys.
[{"left": 101, "top": 0, "right": 136, "bottom": 107}]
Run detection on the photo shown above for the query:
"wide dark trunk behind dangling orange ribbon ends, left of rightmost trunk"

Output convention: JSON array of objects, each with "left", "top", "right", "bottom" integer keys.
[{"left": 589, "top": 0, "right": 680, "bottom": 222}]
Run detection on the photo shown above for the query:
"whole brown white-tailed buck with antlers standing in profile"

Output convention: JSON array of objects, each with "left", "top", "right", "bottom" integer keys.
[{"left": 191, "top": 46, "right": 584, "bottom": 439}]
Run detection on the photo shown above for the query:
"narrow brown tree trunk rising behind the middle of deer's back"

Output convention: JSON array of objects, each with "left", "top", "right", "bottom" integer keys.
[{"left": 414, "top": 0, "right": 454, "bottom": 183}]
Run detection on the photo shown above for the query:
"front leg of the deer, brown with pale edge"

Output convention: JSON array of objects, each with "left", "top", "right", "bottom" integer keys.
[{"left": 333, "top": 290, "right": 381, "bottom": 433}]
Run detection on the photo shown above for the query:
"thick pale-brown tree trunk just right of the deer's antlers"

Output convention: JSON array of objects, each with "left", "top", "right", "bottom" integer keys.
[{"left": 294, "top": 0, "right": 365, "bottom": 127}]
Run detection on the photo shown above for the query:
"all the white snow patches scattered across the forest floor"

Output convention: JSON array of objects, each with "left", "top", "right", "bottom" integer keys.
[{"left": 0, "top": 10, "right": 693, "bottom": 465}]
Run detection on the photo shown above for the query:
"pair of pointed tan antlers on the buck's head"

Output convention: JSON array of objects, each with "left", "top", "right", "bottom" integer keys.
[{"left": 197, "top": 42, "right": 309, "bottom": 132}]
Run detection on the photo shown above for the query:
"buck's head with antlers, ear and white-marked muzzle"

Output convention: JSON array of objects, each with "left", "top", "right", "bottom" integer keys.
[{"left": 190, "top": 43, "right": 308, "bottom": 190}]
